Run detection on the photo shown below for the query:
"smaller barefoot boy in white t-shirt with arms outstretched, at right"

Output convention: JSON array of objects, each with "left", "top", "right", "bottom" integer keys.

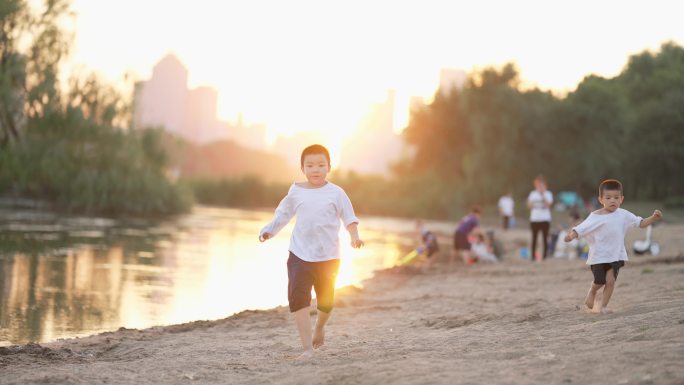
[{"left": 565, "top": 179, "right": 663, "bottom": 313}]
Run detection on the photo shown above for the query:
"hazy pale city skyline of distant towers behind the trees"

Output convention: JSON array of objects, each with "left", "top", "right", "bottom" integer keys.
[{"left": 133, "top": 54, "right": 408, "bottom": 174}]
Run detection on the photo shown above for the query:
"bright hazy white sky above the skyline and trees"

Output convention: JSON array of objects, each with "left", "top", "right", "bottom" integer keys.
[{"left": 70, "top": 0, "right": 684, "bottom": 137}]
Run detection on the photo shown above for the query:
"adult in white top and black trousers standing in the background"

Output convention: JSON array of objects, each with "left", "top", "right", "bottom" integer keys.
[{"left": 527, "top": 175, "right": 553, "bottom": 261}]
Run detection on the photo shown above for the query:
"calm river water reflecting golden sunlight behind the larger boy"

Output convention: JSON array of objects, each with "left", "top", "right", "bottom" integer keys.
[{"left": 0, "top": 207, "right": 413, "bottom": 345}]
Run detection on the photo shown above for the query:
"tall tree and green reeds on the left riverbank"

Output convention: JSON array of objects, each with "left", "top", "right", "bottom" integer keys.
[{"left": 0, "top": 0, "right": 192, "bottom": 216}]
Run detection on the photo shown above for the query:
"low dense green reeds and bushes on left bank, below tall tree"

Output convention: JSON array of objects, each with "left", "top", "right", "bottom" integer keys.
[{"left": 0, "top": 118, "right": 192, "bottom": 215}]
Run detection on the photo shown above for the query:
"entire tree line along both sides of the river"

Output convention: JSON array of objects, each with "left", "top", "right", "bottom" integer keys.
[{"left": 0, "top": 0, "right": 684, "bottom": 219}]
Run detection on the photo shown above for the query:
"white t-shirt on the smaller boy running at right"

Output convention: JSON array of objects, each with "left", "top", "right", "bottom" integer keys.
[{"left": 573, "top": 209, "right": 642, "bottom": 265}]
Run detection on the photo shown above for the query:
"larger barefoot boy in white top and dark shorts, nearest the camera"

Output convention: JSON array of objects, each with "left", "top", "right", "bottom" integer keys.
[{"left": 259, "top": 144, "right": 363, "bottom": 359}]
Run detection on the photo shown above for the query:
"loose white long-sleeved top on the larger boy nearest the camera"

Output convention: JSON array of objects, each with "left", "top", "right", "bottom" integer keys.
[{"left": 260, "top": 182, "right": 359, "bottom": 262}]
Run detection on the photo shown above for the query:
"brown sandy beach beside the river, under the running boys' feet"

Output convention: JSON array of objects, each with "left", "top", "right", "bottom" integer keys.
[{"left": 0, "top": 224, "right": 684, "bottom": 384}]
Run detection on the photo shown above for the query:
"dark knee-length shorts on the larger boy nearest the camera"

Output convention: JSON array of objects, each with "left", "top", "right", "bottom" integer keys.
[{"left": 287, "top": 252, "right": 340, "bottom": 313}]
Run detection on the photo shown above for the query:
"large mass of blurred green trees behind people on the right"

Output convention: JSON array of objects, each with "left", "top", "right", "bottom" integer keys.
[{"left": 396, "top": 43, "right": 684, "bottom": 204}]
